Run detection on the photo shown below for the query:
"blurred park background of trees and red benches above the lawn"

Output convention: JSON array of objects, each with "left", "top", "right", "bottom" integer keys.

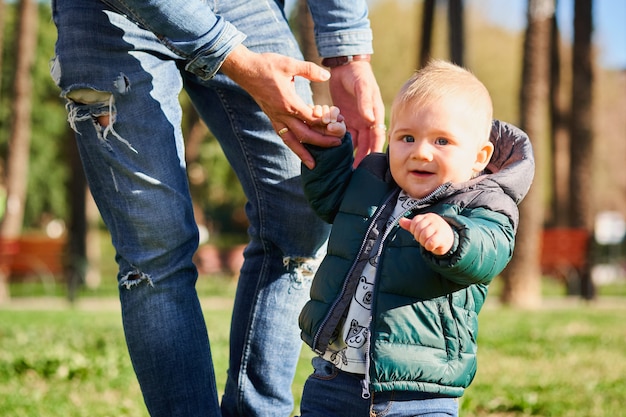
[{"left": 0, "top": 0, "right": 626, "bottom": 307}]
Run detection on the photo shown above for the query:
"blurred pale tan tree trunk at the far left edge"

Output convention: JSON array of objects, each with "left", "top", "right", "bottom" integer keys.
[{"left": 0, "top": 0, "right": 38, "bottom": 302}]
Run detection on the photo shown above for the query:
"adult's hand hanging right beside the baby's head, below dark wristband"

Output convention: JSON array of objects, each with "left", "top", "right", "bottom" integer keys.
[{"left": 329, "top": 61, "right": 386, "bottom": 166}]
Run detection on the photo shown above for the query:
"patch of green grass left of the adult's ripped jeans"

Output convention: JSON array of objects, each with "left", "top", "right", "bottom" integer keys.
[{"left": 0, "top": 305, "right": 147, "bottom": 417}]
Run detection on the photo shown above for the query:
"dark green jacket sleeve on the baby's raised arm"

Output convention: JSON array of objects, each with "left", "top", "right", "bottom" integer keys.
[{"left": 302, "top": 133, "right": 354, "bottom": 223}]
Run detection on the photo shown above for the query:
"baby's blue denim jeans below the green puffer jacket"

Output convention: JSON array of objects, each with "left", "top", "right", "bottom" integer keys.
[{"left": 300, "top": 357, "right": 458, "bottom": 417}]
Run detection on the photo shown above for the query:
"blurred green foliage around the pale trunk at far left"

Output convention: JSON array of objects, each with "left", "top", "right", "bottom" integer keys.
[{"left": 0, "top": 2, "right": 67, "bottom": 230}]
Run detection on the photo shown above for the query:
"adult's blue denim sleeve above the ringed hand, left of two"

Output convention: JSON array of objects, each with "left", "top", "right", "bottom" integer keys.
[{"left": 102, "top": 0, "right": 245, "bottom": 79}]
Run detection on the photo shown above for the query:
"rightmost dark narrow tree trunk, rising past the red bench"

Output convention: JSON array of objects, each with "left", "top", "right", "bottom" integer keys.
[{"left": 569, "top": 0, "right": 595, "bottom": 299}]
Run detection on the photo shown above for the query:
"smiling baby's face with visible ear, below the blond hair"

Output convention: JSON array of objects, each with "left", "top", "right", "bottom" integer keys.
[{"left": 389, "top": 98, "right": 493, "bottom": 198}]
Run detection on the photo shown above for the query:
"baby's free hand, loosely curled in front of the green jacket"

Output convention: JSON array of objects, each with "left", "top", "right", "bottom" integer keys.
[{"left": 399, "top": 213, "right": 454, "bottom": 255}]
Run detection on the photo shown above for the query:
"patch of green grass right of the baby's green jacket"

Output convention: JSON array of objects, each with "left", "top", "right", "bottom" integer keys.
[{"left": 461, "top": 300, "right": 626, "bottom": 417}]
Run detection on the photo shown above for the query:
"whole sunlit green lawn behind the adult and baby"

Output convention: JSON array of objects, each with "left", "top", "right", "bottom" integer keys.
[{"left": 0, "top": 274, "right": 626, "bottom": 417}]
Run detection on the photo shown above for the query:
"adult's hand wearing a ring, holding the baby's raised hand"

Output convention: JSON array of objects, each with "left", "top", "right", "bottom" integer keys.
[{"left": 221, "top": 45, "right": 341, "bottom": 169}]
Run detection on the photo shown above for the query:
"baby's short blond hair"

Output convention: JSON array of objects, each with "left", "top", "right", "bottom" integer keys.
[{"left": 391, "top": 60, "right": 493, "bottom": 140}]
